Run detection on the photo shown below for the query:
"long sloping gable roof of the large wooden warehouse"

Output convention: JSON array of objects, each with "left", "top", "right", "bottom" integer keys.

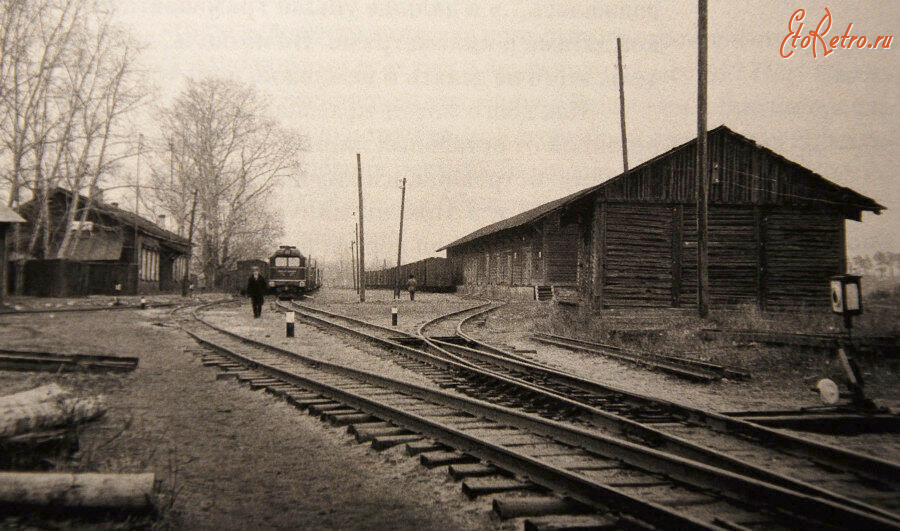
[{"left": 436, "top": 125, "right": 885, "bottom": 252}]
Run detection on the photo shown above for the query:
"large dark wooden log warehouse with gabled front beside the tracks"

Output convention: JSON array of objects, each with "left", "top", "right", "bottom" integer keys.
[{"left": 438, "top": 126, "right": 884, "bottom": 309}]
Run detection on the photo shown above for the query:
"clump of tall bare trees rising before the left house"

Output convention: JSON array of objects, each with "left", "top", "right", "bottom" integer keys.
[{"left": 0, "top": 0, "right": 141, "bottom": 288}]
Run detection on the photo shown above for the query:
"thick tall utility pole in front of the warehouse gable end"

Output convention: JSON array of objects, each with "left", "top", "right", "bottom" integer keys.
[{"left": 696, "top": 0, "right": 709, "bottom": 317}]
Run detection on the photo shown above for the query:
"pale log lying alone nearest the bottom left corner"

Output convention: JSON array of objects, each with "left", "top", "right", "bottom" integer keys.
[{"left": 0, "top": 472, "right": 155, "bottom": 513}]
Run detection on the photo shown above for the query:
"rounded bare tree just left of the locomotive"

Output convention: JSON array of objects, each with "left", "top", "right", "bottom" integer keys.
[{"left": 152, "top": 78, "right": 304, "bottom": 285}]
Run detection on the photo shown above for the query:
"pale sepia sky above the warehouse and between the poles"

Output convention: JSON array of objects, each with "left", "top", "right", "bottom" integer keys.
[{"left": 109, "top": 0, "right": 900, "bottom": 265}]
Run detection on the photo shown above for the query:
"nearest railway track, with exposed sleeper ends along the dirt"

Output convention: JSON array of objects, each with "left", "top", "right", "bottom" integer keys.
[{"left": 180, "top": 302, "right": 898, "bottom": 529}]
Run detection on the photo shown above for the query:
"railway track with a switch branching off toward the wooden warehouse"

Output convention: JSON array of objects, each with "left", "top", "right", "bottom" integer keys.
[{"left": 284, "top": 305, "right": 900, "bottom": 521}]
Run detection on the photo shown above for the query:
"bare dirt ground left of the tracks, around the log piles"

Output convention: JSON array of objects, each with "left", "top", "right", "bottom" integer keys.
[{"left": 0, "top": 303, "right": 500, "bottom": 529}]
